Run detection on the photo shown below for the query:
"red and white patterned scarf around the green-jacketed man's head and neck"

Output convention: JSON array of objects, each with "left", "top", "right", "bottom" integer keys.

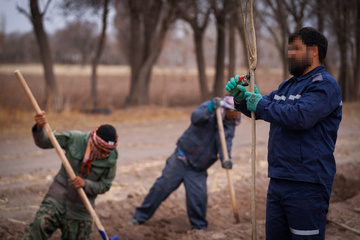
[{"left": 80, "top": 127, "right": 118, "bottom": 177}]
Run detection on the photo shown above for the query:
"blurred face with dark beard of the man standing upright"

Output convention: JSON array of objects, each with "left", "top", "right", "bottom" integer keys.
[{"left": 288, "top": 37, "right": 314, "bottom": 77}]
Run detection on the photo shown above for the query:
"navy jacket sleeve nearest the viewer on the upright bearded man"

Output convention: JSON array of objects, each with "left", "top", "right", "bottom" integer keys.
[{"left": 256, "top": 79, "right": 341, "bottom": 130}]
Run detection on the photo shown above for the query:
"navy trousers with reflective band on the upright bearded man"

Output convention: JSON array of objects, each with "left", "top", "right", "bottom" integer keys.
[{"left": 266, "top": 178, "right": 331, "bottom": 240}]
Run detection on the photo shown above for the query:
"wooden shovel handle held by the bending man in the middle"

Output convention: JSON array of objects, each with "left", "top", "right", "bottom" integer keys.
[{"left": 215, "top": 102, "right": 240, "bottom": 223}]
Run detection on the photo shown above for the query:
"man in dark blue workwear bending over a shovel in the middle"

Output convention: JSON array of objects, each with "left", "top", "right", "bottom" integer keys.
[{"left": 129, "top": 96, "right": 241, "bottom": 230}]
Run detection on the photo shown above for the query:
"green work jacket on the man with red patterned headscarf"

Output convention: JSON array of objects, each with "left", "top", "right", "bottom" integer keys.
[{"left": 33, "top": 125, "right": 118, "bottom": 220}]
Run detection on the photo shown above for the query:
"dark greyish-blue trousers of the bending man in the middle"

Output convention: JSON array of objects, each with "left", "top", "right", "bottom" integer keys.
[{"left": 134, "top": 151, "right": 207, "bottom": 230}]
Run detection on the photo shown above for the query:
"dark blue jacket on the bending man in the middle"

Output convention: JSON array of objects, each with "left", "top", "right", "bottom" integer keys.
[{"left": 177, "top": 101, "right": 235, "bottom": 171}]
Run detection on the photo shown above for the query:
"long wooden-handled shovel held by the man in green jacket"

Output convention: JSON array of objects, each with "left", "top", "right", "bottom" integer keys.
[{"left": 14, "top": 70, "right": 118, "bottom": 240}]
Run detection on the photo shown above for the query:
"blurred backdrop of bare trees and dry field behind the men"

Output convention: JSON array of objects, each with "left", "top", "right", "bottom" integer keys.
[{"left": 0, "top": 0, "right": 360, "bottom": 116}]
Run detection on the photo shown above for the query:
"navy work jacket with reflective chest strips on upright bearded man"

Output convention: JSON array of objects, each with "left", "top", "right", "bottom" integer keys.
[{"left": 235, "top": 65, "right": 342, "bottom": 185}]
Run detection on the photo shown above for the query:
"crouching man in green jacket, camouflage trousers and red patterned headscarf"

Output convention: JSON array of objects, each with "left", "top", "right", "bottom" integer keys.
[{"left": 23, "top": 111, "right": 118, "bottom": 240}]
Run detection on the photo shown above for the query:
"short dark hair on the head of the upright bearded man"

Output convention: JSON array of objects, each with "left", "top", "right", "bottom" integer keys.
[{"left": 288, "top": 27, "right": 328, "bottom": 63}]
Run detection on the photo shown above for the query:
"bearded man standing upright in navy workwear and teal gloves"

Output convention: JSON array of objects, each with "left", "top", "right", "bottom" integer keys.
[{"left": 226, "top": 27, "right": 342, "bottom": 240}]
